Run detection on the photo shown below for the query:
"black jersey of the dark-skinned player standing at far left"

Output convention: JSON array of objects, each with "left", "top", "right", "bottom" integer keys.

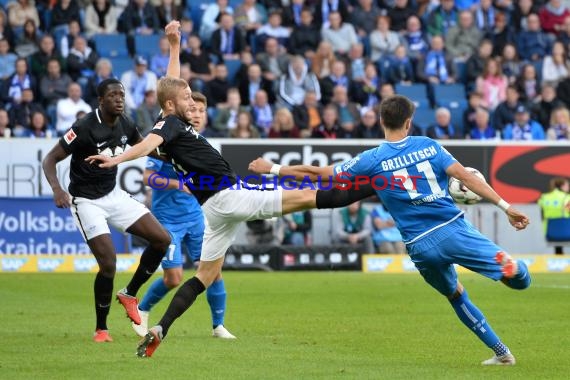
[{"left": 59, "top": 109, "right": 142, "bottom": 199}]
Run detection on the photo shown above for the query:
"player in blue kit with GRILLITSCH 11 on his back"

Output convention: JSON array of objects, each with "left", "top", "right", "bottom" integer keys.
[{"left": 250, "top": 96, "right": 531, "bottom": 365}]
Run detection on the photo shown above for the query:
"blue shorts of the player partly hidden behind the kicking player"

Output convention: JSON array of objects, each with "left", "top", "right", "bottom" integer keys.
[{"left": 162, "top": 218, "right": 205, "bottom": 269}]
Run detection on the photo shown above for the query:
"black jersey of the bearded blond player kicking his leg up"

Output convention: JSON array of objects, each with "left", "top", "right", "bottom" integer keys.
[{"left": 150, "top": 115, "right": 237, "bottom": 204}]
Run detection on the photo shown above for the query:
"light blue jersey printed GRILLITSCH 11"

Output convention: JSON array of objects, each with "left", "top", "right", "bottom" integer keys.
[{"left": 334, "top": 136, "right": 463, "bottom": 244}]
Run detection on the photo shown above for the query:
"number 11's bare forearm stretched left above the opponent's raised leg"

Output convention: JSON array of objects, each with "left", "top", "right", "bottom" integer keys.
[{"left": 249, "top": 157, "right": 334, "bottom": 182}]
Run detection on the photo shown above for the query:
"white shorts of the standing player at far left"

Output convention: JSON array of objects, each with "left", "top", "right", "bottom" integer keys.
[{"left": 71, "top": 186, "right": 149, "bottom": 241}]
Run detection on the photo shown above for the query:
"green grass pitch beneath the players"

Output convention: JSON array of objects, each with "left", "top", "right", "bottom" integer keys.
[{"left": 0, "top": 272, "right": 570, "bottom": 380}]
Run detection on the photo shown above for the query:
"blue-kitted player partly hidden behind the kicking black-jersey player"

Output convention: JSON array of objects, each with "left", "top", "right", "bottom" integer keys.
[{"left": 132, "top": 92, "right": 235, "bottom": 339}]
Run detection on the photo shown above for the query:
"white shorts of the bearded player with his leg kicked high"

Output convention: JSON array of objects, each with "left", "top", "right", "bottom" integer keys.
[{"left": 200, "top": 188, "right": 283, "bottom": 261}]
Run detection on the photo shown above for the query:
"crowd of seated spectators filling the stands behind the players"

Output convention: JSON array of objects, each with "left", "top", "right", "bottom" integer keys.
[{"left": 0, "top": 0, "right": 570, "bottom": 140}]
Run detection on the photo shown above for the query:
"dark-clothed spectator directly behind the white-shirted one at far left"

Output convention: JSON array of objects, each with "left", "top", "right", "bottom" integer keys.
[{"left": 40, "top": 58, "right": 73, "bottom": 112}]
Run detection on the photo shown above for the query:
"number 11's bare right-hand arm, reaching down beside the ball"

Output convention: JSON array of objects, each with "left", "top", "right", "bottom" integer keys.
[{"left": 447, "top": 162, "right": 530, "bottom": 230}]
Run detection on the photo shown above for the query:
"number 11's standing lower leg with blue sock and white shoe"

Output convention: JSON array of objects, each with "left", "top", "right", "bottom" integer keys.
[{"left": 449, "top": 284, "right": 515, "bottom": 365}]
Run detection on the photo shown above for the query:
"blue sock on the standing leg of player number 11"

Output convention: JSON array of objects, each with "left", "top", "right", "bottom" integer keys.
[{"left": 450, "top": 290, "right": 501, "bottom": 348}]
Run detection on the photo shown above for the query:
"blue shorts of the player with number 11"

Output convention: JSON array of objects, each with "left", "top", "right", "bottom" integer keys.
[{"left": 407, "top": 218, "right": 503, "bottom": 296}]
